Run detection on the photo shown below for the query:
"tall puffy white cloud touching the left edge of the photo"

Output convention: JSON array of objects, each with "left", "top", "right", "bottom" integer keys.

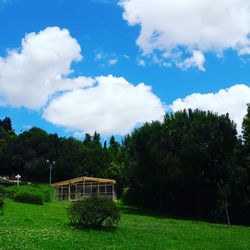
[{"left": 0, "top": 27, "right": 94, "bottom": 109}]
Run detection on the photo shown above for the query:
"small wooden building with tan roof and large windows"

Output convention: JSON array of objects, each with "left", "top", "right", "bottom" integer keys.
[{"left": 52, "top": 177, "right": 116, "bottom": 200}]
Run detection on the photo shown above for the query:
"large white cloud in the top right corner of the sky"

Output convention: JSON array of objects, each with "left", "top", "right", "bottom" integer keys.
[{"left": 119, "top": 0, "right": 250, "bottom": 70}]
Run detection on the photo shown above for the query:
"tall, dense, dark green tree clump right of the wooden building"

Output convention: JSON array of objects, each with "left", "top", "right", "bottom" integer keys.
[{"left": 125, "top": 110, "right": 237, "bottom": 219}]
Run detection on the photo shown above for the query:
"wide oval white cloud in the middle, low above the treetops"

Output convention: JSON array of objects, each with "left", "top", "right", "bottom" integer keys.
[{"left": 44, "top": 75, "right": 165, "bottom": 135}]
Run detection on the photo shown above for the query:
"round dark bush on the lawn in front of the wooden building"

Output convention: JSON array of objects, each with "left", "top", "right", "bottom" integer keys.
[{"left": 68, "top": 196, "right": 120, "bottom": 228}]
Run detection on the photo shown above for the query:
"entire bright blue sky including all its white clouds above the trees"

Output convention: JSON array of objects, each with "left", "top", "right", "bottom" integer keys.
[{"left": 0, "top": 0, "right": 250, "bottom": 137}]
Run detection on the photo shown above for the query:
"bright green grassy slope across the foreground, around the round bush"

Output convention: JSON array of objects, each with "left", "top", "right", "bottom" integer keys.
[{"left": 0, "top": 201, "right": 250, "bottom": 250}]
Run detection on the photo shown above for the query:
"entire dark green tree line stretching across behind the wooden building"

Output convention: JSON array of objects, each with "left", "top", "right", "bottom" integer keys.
[{"left": 0, "top": 105, "right": 250, "bottom": 225}]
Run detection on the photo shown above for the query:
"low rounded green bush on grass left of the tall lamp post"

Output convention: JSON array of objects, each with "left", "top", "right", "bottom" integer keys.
[{"left": 13, "top": 191, "right": 43, "bottom": 205}]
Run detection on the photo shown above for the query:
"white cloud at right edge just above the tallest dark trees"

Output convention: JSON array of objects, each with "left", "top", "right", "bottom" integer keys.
[{"left": 170, "top": 84, "right": 250, "bottom": 133}]
